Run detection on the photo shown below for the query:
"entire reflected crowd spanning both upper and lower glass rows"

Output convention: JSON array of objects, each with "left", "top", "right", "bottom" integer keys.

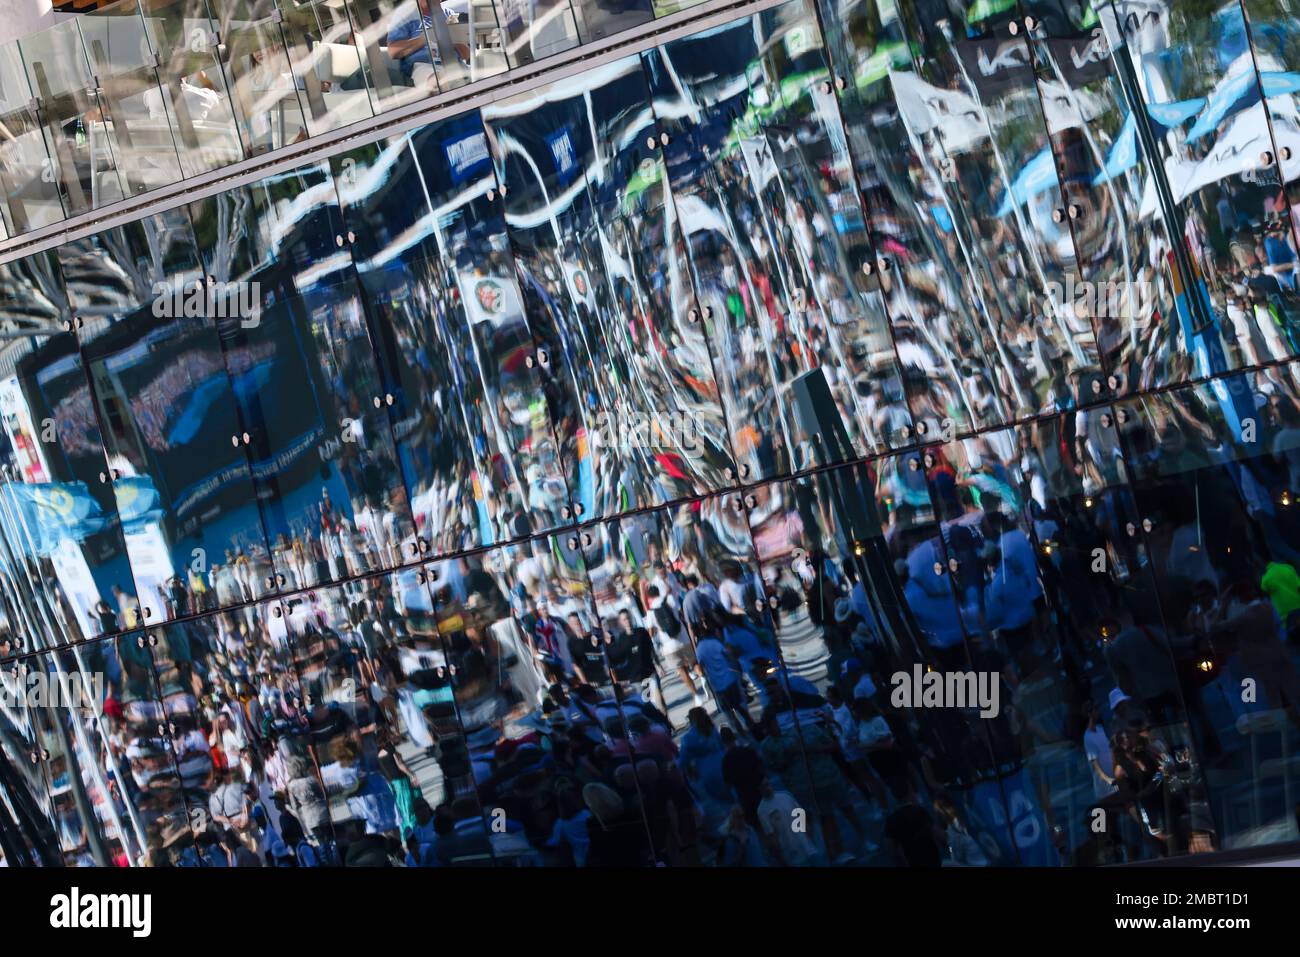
[{"left": 10, "top": 4, "right": 1300, "bottom": 867}]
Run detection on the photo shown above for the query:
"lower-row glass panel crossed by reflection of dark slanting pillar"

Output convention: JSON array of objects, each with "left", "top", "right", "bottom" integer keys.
[{"left": 750, "top": 452, "right": 1013, "bottom": 866}]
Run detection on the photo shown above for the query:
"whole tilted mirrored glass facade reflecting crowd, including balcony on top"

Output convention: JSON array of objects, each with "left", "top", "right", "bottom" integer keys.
[{"left": 0, "top": 0, "right": 1300, "bottom": 867}]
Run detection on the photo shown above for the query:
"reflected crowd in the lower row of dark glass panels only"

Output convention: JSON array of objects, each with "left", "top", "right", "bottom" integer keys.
[{"left": 20, "top": 345, "right": 1300, "bottom": 866}]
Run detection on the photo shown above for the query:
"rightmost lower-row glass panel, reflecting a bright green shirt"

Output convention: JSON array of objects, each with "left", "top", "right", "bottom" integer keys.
[{"left": 1119, "top": 374, "right": 1300, "bottom": 846}]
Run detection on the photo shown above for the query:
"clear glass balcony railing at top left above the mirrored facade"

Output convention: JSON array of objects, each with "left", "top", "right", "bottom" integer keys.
[{"left": 0, "top": 0, "right": 712, "bottom": 242}]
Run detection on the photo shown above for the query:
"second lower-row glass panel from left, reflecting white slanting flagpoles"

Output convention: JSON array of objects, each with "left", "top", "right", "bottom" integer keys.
[{"left": 33, "top": 633, "right": 195, "bottom": 867}]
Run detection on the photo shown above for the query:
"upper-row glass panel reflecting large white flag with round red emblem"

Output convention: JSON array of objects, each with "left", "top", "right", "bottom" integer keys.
[{"left": 334, "top": 114, "right": 569, "bottom": 554}]
